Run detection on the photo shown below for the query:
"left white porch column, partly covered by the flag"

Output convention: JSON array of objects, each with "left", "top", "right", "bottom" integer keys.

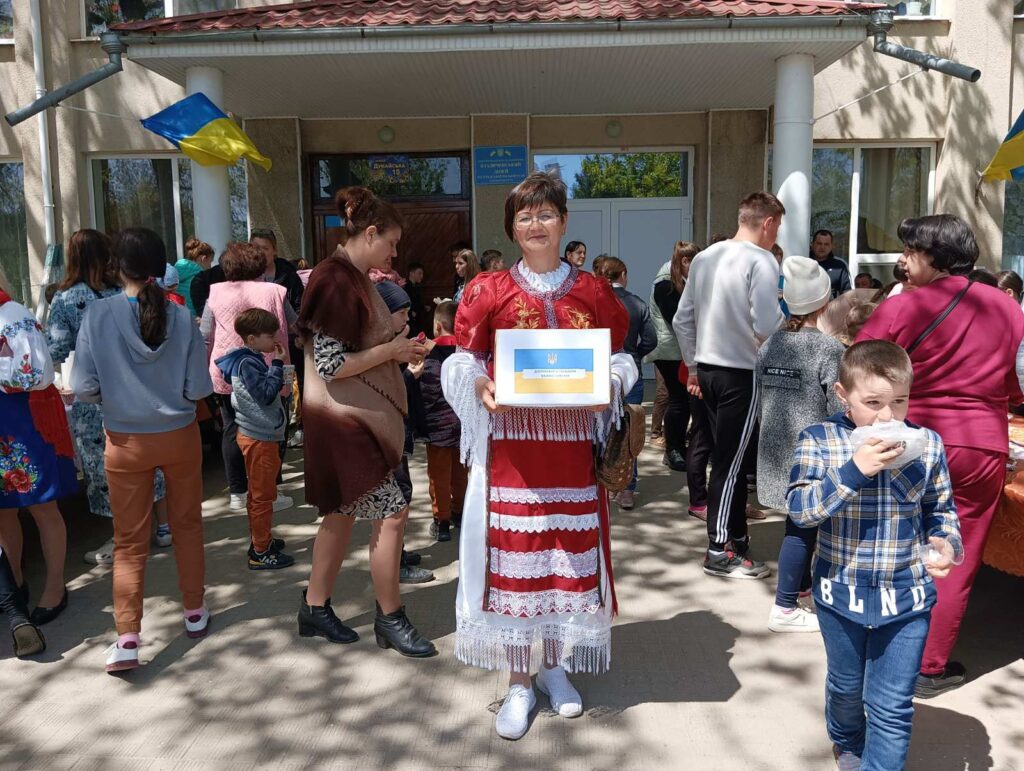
[{"left": 183, "top": 67, "right": 231, "bottom": 259}]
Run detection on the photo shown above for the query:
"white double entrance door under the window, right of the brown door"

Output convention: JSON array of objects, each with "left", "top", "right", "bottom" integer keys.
[{"left": 561, "top": 198, "right": 693, "bottom": 378}]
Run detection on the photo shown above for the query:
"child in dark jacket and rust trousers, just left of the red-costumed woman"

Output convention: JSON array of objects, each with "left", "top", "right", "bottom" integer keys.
[{"left": 420, "top": 300, "right": 469, "bottom": 541}]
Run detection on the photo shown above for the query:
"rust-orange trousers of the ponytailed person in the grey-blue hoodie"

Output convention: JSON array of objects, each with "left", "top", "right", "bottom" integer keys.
[{"left": 103, "top": 423, "right": 206, "bottom": 635}]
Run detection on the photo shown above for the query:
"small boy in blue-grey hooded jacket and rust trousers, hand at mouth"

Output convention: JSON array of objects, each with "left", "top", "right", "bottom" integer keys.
[{"left": 216, "top": 308, "right": 295, "bottom": 570}]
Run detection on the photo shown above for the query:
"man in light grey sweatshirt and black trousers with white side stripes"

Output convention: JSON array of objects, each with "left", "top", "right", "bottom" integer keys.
[{"left": 673, "top": 192, "right": 785, "bottom": 579}]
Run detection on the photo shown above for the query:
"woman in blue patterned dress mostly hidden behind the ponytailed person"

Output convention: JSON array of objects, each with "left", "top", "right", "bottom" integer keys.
[{"left": 46, "top": 229, "right": 170, "bottom": 565}]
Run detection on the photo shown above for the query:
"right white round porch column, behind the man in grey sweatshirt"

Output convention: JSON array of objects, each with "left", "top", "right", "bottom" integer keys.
[{"left": 772, "top": 53, "right": 814, "bottom": 257}]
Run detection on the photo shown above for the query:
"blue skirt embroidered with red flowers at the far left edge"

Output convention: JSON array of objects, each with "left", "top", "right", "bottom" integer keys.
[{"left": 0, "top": 393, "right": 78, "bottom": 509}]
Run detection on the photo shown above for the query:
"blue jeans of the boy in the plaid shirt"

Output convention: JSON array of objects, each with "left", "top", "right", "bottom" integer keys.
[{"left": 817, "top": 603, "right": 931, "bottom": 771}]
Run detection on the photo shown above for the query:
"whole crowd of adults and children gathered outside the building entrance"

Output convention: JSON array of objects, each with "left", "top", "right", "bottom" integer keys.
[{"left": 0, "top": 172, "right": 1024, "bottom": 769}]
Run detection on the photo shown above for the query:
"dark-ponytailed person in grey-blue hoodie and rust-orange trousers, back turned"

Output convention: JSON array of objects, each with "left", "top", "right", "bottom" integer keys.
[{"left": 72, "top": 227, "right": 213, "bottom": 672}]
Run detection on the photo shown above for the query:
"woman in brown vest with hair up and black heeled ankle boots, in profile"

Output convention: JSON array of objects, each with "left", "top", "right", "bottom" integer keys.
[{"left": 299, "top": 187, "right": 437, "bottom": 657}]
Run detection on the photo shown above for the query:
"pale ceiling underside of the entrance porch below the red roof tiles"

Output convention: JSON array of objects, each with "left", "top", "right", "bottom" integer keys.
[{"left": 122, "top": 19, "right": 866, "bottom": 118}]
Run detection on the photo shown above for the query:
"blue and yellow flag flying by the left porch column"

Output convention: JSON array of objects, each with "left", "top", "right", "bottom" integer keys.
[{"left": 140, "top": 92, "right": 270, "bottom": 171}]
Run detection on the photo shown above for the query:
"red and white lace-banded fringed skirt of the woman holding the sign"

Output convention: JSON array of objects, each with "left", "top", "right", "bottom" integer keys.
[{"left": 456, "top": 411, "right": 614, "bottom": 673}]
